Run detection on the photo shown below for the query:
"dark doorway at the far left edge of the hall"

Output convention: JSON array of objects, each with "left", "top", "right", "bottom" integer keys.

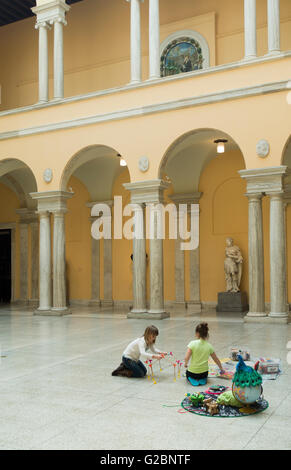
[{"left": 0, "top": 230, "right": 11, "bottom": 304}]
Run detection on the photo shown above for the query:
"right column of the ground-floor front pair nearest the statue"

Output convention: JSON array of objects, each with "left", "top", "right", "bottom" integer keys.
[{"left": 269, "top": 192, "right": 288, "bottom": 318}]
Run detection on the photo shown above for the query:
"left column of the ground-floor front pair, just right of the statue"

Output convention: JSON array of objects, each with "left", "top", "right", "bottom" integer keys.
[{"left": 247, "top": 193, "right": 266, "bottom": 317}]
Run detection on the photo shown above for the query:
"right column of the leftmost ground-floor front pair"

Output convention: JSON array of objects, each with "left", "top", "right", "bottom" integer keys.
[{"left": 52, "top": 209, "right": 68, "bottom": 313}]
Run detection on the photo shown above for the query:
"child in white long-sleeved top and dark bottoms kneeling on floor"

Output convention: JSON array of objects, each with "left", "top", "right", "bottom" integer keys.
[{"left": 112, "top": 325, "right": 167, "bottom": 377}]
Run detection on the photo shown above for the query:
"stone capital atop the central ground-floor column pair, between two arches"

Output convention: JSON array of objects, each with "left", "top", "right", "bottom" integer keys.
[{"left": 123, "top": 179, "right": 170, "bottom": 204}]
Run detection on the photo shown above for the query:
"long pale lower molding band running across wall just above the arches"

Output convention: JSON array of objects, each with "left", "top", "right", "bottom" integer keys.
[{"left": 0, "top": 80, "right": 290, "bottom": 141}]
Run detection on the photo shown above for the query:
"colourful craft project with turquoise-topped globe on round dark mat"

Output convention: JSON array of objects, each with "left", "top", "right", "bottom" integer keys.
[{"left": 181, "top": 355, "right": 269, "bottom": 418}]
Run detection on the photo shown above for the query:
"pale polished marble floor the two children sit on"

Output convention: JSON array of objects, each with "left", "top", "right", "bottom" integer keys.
[{"left": 0, "top": 307, "right": 291, "bottom": 450}]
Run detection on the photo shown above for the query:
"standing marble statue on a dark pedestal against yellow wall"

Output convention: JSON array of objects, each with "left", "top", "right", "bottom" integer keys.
[{"left": 224, "top": 238, "right": 243, "bottom": 292}]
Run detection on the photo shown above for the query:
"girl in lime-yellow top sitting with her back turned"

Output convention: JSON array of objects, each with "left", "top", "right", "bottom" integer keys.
[{"left": 184, "top": 323, "right": 224, "bottom": 386}]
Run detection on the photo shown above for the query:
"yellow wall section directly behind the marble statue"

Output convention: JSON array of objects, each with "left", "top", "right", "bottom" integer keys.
[{"left": 199, "top": 151, "right": 248, "bottom": 302}]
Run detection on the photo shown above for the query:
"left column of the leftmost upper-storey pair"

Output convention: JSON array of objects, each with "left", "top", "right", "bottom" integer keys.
[{"left": 35, "top": 22, "right": 49, "bottom": 103}]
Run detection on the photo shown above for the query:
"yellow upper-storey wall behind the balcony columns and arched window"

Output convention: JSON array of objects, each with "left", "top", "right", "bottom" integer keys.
[{"left": 0, "top": 0, "right": 291, "bottom": 109}]
